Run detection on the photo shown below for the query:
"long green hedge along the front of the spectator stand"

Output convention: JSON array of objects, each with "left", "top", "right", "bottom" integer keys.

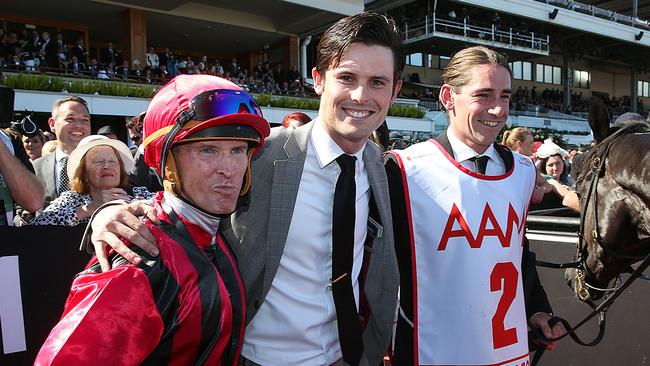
[{"left": 3, "top": 74, "right": 425, "bottom": 118}]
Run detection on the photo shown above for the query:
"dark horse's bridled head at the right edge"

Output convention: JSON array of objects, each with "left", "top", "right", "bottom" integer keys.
[{"left": 567, "top": 98, "right": 650, "bottom": 301}]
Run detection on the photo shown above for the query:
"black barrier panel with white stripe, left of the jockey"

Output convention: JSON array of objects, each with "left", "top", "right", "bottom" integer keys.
[{"left": 0, "top": 225, "right": 90, "bottom": 365}]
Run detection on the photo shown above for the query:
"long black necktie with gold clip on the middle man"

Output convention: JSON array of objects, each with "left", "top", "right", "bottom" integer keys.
[{"left": 332, "top": 154, "right": 363, "bottom": 366}]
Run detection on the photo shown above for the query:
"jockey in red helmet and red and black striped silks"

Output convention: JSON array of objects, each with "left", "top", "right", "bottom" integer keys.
[{"left": 35, "top": 75, "right": 269, "bottom": 365}]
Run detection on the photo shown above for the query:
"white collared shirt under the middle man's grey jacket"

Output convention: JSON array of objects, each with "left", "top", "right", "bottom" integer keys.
[{"left": 242, "top": 119, "right": 370, "bottom": 366}]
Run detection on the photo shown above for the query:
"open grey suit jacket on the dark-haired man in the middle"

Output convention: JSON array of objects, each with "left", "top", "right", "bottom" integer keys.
[{"left": 221, "top": 123, "right": 399, "bottom": 365}]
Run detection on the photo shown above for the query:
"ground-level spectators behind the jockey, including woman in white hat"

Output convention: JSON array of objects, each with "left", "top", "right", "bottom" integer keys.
[{"left": 0, "top": 96, "right": 318, "bottom": 226}]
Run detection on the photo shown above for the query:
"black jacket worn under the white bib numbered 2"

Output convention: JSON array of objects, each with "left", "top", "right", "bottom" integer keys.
[{"left": 385, "top": 133, "right": 552, "bottom": 365}]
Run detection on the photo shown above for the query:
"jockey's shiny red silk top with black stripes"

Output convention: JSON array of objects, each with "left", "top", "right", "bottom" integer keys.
[{"left": 35, "top": 192, "right": 245, "bottom": 365}]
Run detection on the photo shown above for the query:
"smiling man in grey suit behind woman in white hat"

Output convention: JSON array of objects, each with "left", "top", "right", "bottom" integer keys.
[{"left": 34, "top": 96, "right": 90, "bottom": 212}]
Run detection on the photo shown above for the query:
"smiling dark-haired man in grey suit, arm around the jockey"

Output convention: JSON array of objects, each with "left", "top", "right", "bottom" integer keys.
[{"left": 86, "top": 13, "right": 403, "bottom": 365}]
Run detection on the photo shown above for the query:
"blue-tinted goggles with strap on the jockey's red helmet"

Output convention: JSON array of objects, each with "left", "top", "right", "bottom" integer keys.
[{"left": 160, "top": 89, "right": 262, "bottom": 172}]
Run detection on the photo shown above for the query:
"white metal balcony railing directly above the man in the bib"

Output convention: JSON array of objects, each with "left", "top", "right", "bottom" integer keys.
[{"left": 404, "top": 13, "right": 550, "bottom": 53}]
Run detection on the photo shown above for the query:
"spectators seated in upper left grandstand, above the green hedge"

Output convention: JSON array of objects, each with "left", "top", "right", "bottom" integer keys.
[{"left": 0, "top": 29, "right": 306, "bottom": 96}]
